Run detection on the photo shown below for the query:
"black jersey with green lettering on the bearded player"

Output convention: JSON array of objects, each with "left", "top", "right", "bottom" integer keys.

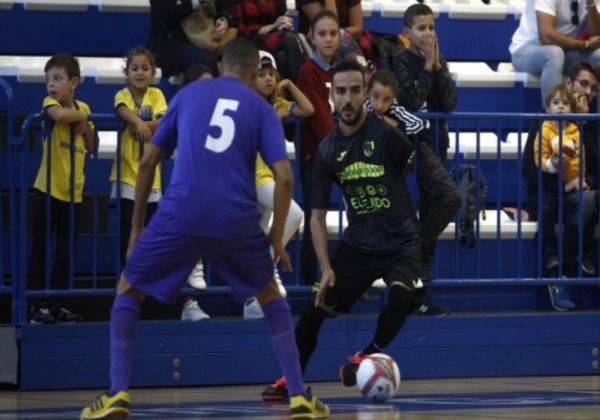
[{"left": 312, "top": 112, "right": 419, "bottom": 252}]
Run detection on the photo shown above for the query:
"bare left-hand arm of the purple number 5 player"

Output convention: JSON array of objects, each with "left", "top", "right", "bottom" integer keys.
[{"left": 127, "top": 143, "right": 165, "bottom": 257}]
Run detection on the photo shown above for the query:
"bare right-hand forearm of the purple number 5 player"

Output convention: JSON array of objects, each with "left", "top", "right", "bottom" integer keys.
[{"left": 269, "top": 160, "right": 294, "bottom": 271}]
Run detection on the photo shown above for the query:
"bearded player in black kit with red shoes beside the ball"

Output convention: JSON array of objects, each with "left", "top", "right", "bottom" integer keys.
[{"left": 262, "top": 61, "right": 420, "bottom": 401}]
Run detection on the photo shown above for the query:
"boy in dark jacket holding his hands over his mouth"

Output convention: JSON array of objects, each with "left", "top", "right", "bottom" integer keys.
[{"left": 391, "top": 4, "right": 460, "bottom": 314}]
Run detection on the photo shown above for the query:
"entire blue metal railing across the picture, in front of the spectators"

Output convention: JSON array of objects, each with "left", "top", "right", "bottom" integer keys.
[{"left": 4, "top": 113, "right": 600, "bottom": 324}]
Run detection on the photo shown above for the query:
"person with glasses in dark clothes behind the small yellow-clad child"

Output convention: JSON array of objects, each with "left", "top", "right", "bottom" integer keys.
[{"left": 522, "top": 61, "right": 600, "bottom": 275}]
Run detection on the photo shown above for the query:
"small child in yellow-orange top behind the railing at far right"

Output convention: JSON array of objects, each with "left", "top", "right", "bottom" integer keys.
[{"left": 533, "top": 84, "right": 596, "bottom": 311}]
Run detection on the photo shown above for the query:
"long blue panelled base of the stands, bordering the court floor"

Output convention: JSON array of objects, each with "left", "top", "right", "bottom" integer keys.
[{"left": 20, "top": 312, "right": 600, "bottom": 390}]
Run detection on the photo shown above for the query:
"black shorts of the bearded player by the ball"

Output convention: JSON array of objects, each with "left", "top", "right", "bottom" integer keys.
[{"left": 325, "top": 241, "right": 420, "bottom": 313}]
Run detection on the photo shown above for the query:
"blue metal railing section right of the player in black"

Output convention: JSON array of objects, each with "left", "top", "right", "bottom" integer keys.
[{"left": 428, "top": 113, "right": 600, "bottom": 285}]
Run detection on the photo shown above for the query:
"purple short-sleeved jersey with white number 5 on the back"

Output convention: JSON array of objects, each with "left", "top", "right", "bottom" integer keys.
[{"left": 152, "top": 77, "right": 286, "bottom": 238}]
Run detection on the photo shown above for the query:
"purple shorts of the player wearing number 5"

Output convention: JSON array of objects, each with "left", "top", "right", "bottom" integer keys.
[{"left": 123, "top": 216, "right": 273, "bottom": 303}]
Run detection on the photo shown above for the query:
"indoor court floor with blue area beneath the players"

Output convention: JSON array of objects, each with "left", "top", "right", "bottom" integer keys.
[{"left": 0, "top": 375, "right": 600, "bottom": 420}]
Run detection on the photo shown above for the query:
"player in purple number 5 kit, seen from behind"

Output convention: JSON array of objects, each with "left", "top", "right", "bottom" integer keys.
[{"left": 81, "top": 38, "right": 329, "bottom": 419}]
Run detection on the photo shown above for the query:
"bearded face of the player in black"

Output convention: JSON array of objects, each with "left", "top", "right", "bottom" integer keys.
[{"left": 332, "top": 71, "right": 366, "bottom": 126}]
